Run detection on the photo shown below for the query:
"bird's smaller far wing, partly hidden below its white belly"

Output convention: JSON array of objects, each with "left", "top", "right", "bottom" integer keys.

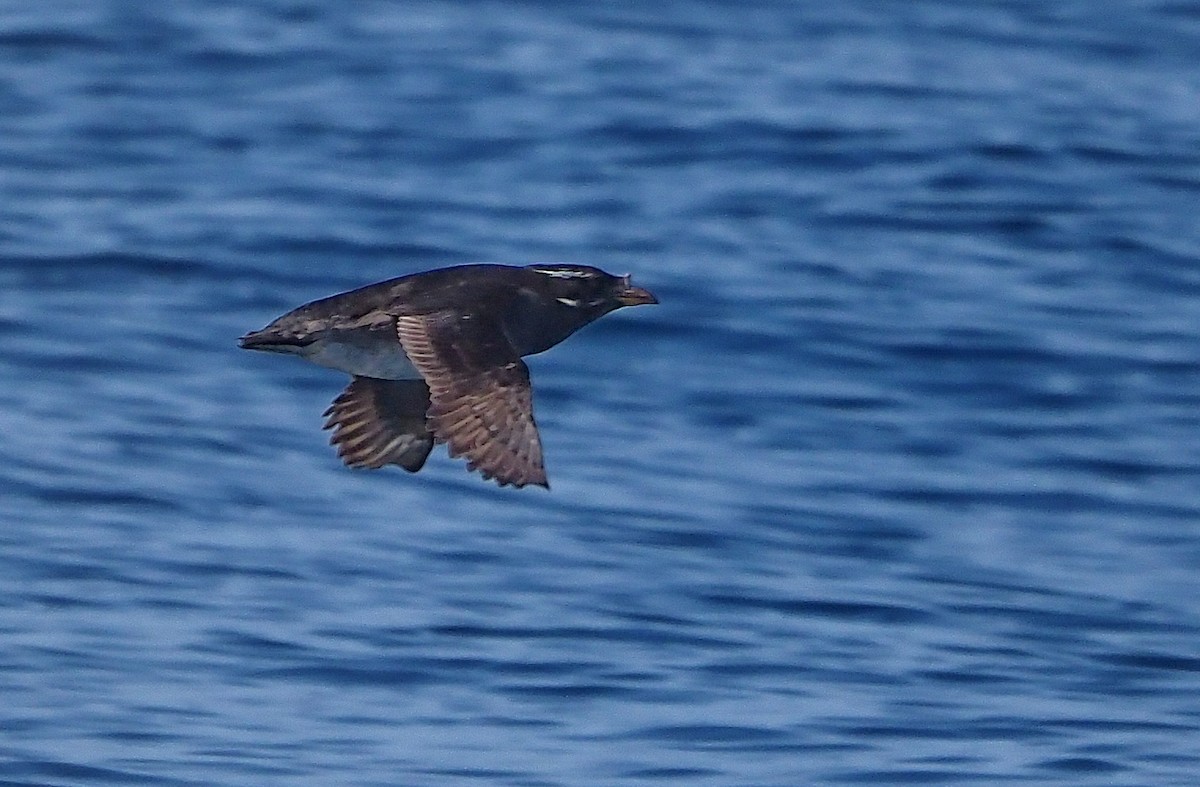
[{"left": 325, "top": 377, "right": 433, "bottom": 473}]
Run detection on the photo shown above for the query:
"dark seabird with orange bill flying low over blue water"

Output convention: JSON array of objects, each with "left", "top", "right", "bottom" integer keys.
[{"left": 239, "top": 264, "right": 659, "bottom": 489}]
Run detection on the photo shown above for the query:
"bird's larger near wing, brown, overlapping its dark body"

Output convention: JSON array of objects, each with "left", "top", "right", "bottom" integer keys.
[{"left": 396, "top": 310, "right": 550, "bottom": 487}]
